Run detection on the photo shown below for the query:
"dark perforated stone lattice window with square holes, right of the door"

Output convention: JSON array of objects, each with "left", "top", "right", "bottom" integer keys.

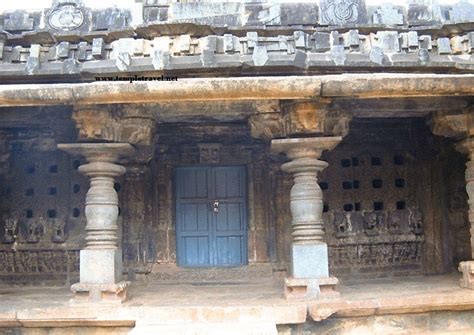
[{"left": 319, "top": 149, "right": 413, "bottom": 212}]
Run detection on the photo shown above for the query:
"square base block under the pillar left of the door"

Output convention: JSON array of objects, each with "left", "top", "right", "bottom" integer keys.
[{"left": 69, "top": 281, "right": 130, "bottom": 305}]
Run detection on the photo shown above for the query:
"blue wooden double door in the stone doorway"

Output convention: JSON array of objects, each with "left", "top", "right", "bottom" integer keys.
[{"left": 175, "top": 166, "right": 247, "bottom": 267}]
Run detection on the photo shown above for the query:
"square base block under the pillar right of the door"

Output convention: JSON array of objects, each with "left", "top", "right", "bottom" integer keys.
[{"left": 285, "top": 277, "right": 340, "bottom": 300}]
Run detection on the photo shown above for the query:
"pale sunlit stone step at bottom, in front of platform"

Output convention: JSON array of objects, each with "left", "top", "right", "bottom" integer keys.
[{"left": 129, "top": 322, "right": 278, "bottom": 335}]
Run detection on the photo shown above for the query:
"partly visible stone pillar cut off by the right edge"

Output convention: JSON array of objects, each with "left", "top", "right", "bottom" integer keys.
[{"left": 458, "top": 137, "right": 474, "bottom": 290}]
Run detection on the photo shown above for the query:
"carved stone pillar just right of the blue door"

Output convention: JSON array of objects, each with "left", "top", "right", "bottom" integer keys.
[{"left": 272, "top": 136, "right": 342, "bottom": 299}]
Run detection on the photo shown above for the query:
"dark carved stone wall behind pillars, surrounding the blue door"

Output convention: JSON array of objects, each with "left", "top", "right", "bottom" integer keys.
[{"left": 0, "top": 115, "right": 470, "bottom": 282}]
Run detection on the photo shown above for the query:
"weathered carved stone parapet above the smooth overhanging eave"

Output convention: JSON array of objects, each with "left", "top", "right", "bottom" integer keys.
[{"left": 0, "top": 0, "right": 474, "bottom": 83}]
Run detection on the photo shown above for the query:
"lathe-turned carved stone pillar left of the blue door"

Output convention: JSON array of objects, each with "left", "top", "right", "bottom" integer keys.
[{"left": 58, "top": 143, "right": 134, "bottom": 303}]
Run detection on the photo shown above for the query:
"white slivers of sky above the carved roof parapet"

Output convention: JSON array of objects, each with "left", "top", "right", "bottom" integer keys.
[{"left": 0, "top": 0, "right": 468, "bottom": 11}]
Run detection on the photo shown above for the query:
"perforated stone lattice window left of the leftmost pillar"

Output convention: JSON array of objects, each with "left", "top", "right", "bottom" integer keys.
[{"left": 0, "top": 151, "right": 92, "bottom": 245}]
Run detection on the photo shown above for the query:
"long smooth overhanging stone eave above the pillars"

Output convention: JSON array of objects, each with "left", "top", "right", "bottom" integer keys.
[{"left": 0, "top": 73, "right": 474, "bottom": 107}]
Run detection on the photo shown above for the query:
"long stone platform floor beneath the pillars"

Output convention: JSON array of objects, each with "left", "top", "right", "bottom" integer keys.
[{"left": 0, "top": 275, "right": 474, "bottom": 334}]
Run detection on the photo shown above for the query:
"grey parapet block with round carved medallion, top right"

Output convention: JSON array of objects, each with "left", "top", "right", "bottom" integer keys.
[{"left": 319, "top": 0, "right": 367, "bottom": 26}]
